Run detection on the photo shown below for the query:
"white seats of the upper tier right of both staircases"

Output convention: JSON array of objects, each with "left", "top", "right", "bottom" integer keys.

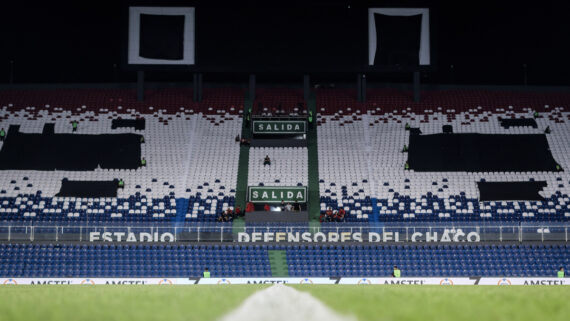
[{"left": 318, "top": 107, "right": 570, "bottom": 219}]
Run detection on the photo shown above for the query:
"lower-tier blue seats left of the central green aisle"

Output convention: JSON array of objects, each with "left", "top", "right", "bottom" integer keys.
[{"left": 0, "top": 244, "right": 271, "bottom": 277}]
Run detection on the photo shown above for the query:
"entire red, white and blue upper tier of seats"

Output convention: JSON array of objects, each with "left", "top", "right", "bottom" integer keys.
[{"left": 0, "top": 89, "right": 570, "bottom": 223}]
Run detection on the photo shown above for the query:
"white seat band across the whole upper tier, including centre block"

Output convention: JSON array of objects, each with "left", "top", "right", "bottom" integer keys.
[{"left": 0, "top": 96, "right": 570, "bottom": 221}]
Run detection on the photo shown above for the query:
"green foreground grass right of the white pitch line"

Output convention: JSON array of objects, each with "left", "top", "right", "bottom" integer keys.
[{"left": 294, "top": 285, "right": 570, "bottom": 321}]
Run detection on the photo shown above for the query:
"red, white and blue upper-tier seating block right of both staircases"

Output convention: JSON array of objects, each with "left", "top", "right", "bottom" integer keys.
[{"left": 317, "top": 89, "right": 570, "bottom": 223}]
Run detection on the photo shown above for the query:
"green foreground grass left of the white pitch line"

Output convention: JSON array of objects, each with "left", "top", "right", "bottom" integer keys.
[{"left": 0, "top": 285, "right": 267, "bottom": 321}]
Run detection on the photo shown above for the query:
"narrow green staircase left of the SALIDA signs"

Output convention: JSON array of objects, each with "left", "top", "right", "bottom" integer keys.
[{"left": 232, "top": 94, "right": 253, "bottom": 235}]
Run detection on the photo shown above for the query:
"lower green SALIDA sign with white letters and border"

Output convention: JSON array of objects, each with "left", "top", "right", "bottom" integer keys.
[{"left": 248, "top": 186, "right": 307, "bottom": 203}]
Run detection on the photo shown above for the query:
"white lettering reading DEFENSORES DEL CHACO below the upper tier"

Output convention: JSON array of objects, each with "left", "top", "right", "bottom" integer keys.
[{"left": 238, "top": 230, "right": 481, "bottom": 243}]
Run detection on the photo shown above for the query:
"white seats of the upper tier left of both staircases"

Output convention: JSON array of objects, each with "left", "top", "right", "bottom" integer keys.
[{"left": 0, "top": 102, "right": 241, "bottom": 220}]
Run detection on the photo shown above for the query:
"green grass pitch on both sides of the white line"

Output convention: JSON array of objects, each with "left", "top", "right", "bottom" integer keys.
[{"left": 0, "top": 285, "right": 570, "bottom": 321}]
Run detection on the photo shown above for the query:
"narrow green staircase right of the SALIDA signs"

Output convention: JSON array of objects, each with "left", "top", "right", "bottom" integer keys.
[{"left": 307, "top": 93, "right": 321, "bottom": 228}]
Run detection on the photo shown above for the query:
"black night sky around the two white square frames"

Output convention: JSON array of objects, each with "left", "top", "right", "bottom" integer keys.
[{"left": 0, "top": 0, "right": 570, "bottom": 85}]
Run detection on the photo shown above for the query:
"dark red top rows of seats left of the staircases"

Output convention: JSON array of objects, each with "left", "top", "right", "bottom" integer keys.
[{"left": 0, "top": 88, "right": 243, "bottom": 115}]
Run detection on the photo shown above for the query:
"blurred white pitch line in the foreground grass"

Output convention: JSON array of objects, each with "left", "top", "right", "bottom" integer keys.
[{"left": 220, "top": 284, "right": 356, "bottom": 321}]
